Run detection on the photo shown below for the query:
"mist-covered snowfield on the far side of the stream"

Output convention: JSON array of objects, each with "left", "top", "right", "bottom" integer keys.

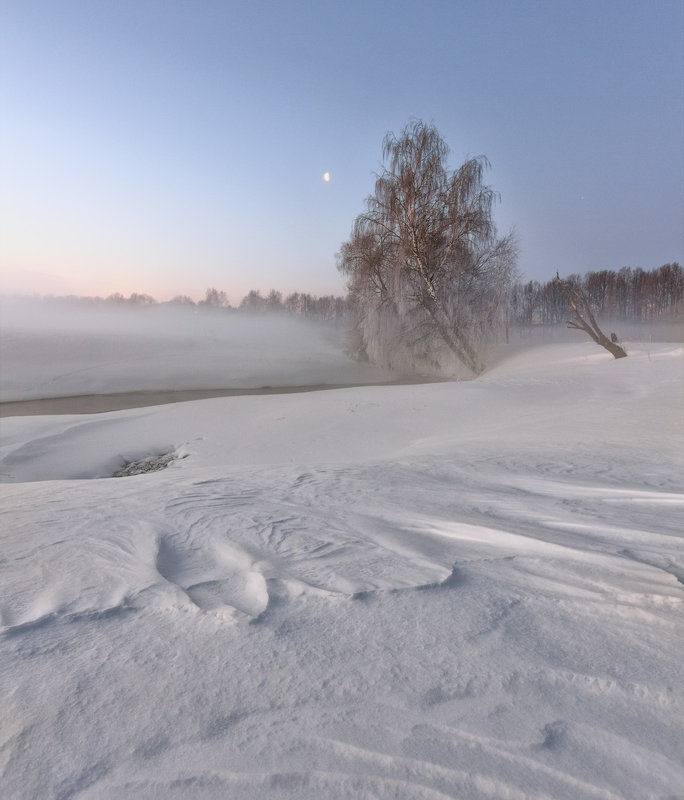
[{"left": 0, "top": 298, "right": 393, "bottom": 401}]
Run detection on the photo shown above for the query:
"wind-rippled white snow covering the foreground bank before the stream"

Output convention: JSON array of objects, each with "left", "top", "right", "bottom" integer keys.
[{"left": 0, "top": 346, "right": 684, "bottom": 800}]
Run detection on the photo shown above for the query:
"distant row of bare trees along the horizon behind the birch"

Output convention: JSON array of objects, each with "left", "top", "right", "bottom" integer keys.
[{"left": 38, "top": 263, "right": 684, "bottom": 328}]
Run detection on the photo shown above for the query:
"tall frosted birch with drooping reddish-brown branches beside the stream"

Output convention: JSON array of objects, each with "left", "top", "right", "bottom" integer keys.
[{"left": 338, "top": 121, "right": 516, "bottom": 375}]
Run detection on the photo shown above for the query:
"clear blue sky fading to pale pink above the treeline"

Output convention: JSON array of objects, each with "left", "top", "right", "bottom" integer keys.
[{"left": 0, "top": 0, "right": 684, "bottom": 303}]
